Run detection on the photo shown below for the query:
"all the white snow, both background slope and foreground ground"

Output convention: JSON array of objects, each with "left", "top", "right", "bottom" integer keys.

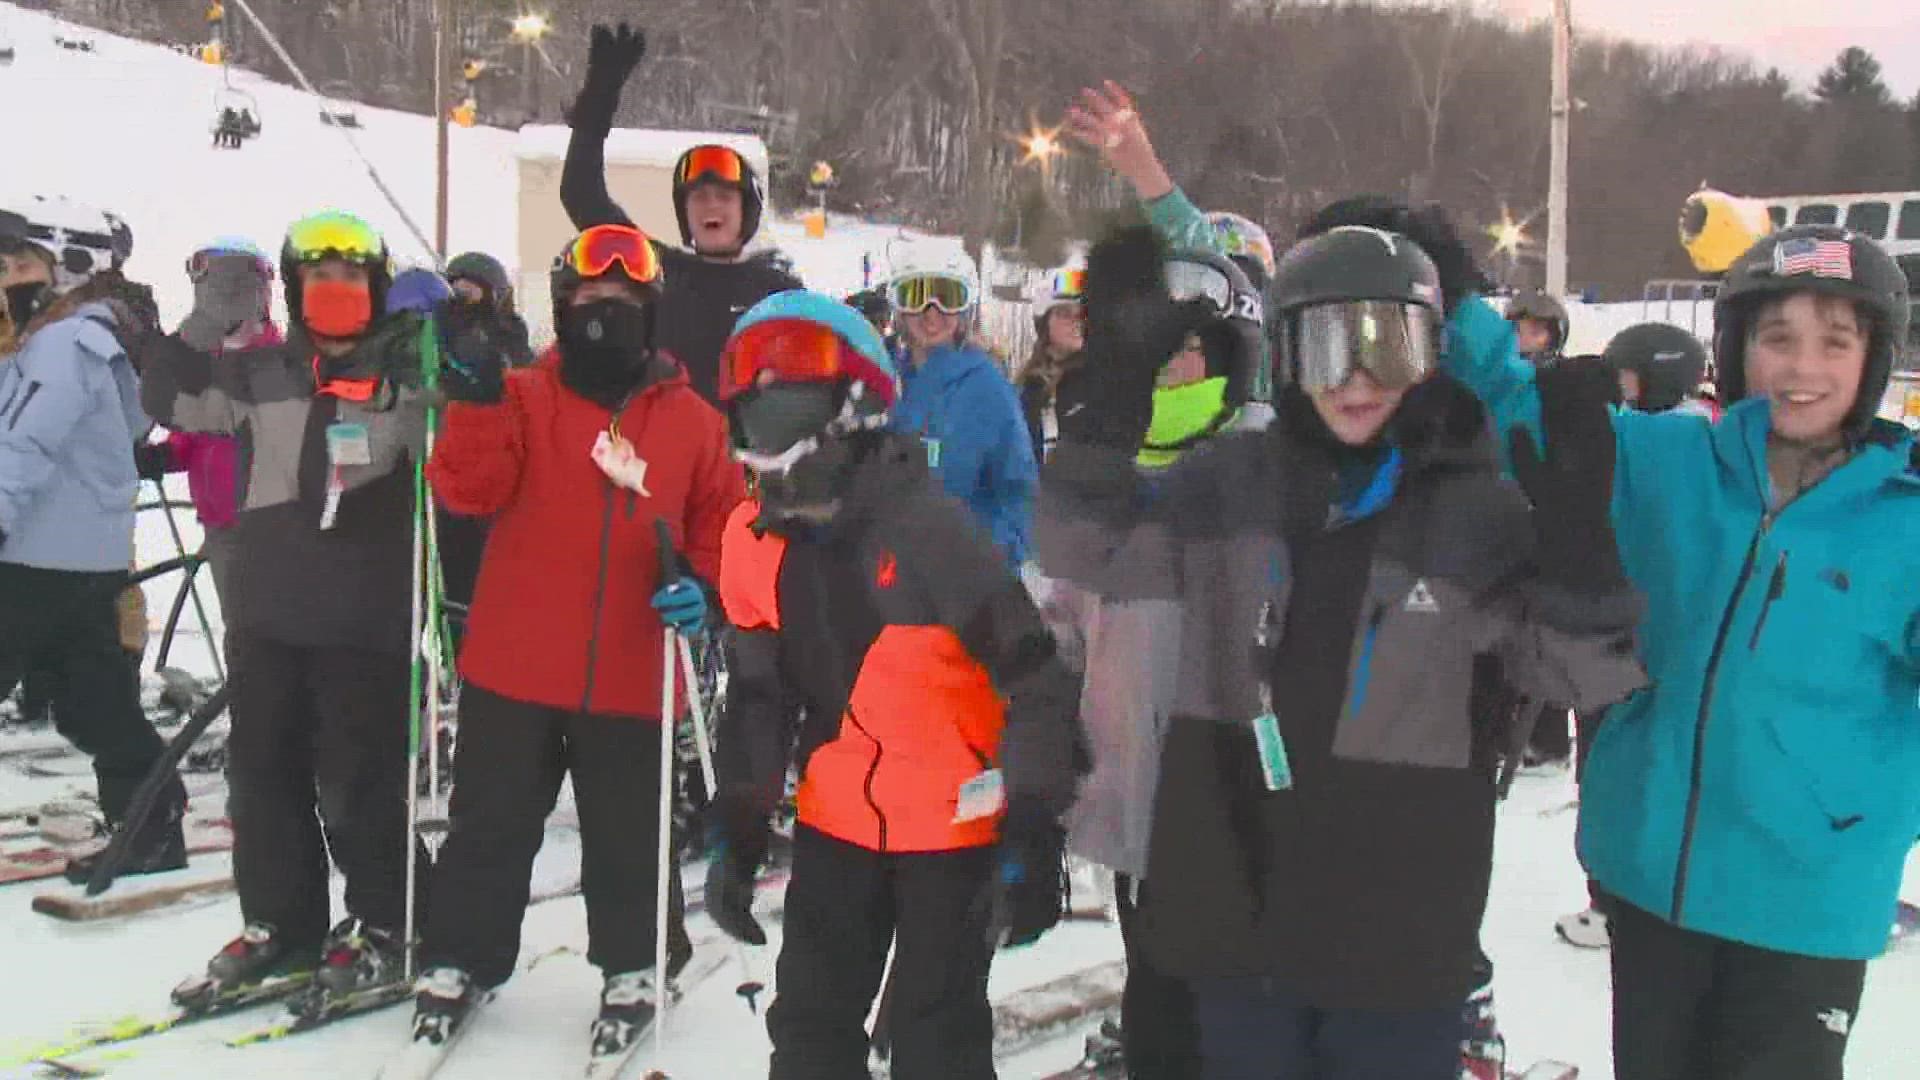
[{"left": 0, "top": 4, "right": 1920, "bottom": 1080}]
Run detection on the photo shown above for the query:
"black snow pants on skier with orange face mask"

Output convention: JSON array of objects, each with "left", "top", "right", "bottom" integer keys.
[{"left": 227, "top": 632, "right": 424, "bottom": 949}]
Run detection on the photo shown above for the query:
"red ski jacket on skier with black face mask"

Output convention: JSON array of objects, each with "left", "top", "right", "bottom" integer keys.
[{"left": 426, "top": 345, "right": 745, "bottom": 719}]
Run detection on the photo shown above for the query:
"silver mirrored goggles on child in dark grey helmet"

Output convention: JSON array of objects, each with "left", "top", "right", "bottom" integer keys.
[{"left": 1288, "top": 300, "right": 1440, "bottom": 394}]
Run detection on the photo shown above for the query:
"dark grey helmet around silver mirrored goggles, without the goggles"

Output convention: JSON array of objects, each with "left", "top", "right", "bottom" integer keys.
[{"left": 1267, "top": 225, "right": 1446, "bottom": 382}]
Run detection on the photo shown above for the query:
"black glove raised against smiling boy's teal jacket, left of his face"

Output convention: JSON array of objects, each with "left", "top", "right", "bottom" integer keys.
[{"left": 1509, "top": 357, "right": 1626, "bottom": 596}]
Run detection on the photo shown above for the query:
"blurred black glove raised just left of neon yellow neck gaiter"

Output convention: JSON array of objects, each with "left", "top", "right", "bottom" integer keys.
[{"left": 1054, "top": 225, "right": 1206, "bottom": 455}]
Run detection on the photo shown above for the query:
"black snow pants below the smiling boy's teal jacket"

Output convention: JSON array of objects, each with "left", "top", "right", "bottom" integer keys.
[{"left": 1601, "top": 896, "right": 1866, "bottom": 1080}]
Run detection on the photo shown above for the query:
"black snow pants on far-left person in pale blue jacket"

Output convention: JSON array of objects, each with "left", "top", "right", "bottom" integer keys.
[{"left": 0, "top": 563, "right": 173, "bottom": 821}]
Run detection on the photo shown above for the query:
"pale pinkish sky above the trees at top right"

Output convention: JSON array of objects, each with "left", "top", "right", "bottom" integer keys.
[{"left": 1492, "top": 0, "right": 1920, "bottom": 100}]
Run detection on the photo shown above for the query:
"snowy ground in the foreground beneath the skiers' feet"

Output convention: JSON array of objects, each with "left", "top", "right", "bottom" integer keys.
[{"left": 0, "top": 753, "right": 1920, "bottom": 1080}]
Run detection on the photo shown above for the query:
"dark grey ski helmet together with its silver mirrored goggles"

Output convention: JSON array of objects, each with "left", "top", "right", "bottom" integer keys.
[{"left": 1267, "top": 225, "right": 1444, "bottom": 392}]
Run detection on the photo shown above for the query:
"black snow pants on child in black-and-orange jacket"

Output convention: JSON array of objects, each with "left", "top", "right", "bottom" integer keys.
[{"left": 766, "top": 824, "right": 995, "bottom": 1080}]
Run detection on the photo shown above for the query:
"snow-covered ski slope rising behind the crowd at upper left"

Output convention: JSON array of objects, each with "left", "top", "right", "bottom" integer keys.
[{"left": 0, "top": 4, "right": 936, "bottom": 323}]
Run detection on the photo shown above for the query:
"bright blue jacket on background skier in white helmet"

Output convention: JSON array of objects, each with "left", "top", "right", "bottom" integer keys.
[{"left": 893, "top": 346, "right": 1041, "bottom": 567}]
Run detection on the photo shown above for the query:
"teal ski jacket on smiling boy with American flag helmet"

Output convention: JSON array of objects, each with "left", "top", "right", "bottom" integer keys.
[{"left": 1446, "top": 315, "right": 1920, "bottom": 959}]
